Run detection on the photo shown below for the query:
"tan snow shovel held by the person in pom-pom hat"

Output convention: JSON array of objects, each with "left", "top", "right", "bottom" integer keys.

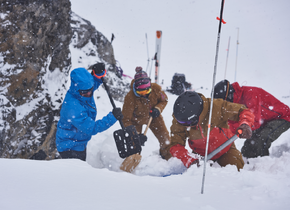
[{"left": 120, "top": 117, "right": 153, "bottom": 173}]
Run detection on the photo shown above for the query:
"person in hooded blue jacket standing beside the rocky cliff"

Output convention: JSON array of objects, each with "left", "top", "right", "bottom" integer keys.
[{"left": 56, "top": 63, "right": 123, "bottom": 161}]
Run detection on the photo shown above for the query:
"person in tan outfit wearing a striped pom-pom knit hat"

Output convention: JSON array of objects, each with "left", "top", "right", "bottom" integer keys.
[{"left": 122, "top": 67, "right": 171, "bottom": 159}]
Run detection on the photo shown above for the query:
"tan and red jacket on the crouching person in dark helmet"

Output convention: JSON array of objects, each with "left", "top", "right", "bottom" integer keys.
[{"left": 168, "top": 94, "right": 253, "bottom": 159}]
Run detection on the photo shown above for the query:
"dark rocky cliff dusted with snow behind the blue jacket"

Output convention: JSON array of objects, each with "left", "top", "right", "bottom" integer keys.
[{"left": 0, "top": 0, "right": 128, "bottom": 159}]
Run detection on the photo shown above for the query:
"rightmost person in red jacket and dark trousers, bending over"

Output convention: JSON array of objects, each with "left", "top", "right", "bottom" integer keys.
[{"left": 214, "top": 80, "right": 290, "bottom": 158}]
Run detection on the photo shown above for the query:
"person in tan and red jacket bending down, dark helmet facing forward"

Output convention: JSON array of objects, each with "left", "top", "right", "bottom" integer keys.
[{"left": 168, "top": 91, "right": 254, "bottom": 170}]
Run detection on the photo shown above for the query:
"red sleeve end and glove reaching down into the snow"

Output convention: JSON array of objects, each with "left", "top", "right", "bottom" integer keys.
[{"left": 170, "top": 144, "right": 199, "bottom": 168}]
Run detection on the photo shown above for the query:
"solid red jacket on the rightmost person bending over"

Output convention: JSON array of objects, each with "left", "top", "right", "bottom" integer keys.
[{"left": 229, "top": 82, "right": 290, "bottom": 133}]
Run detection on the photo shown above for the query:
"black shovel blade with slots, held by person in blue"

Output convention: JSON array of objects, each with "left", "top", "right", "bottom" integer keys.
[{"left": 114, "top": 125, "right": 142, "bottom": 158}]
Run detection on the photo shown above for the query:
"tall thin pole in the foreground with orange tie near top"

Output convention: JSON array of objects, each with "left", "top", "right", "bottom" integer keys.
[{"left": 201, "top": 0, "right": 224, "bottom": 194}]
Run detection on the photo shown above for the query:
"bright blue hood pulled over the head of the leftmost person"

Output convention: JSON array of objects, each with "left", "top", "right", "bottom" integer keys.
[{"left": 69, "top": 68, "right": 94, "bottom": 95}]
